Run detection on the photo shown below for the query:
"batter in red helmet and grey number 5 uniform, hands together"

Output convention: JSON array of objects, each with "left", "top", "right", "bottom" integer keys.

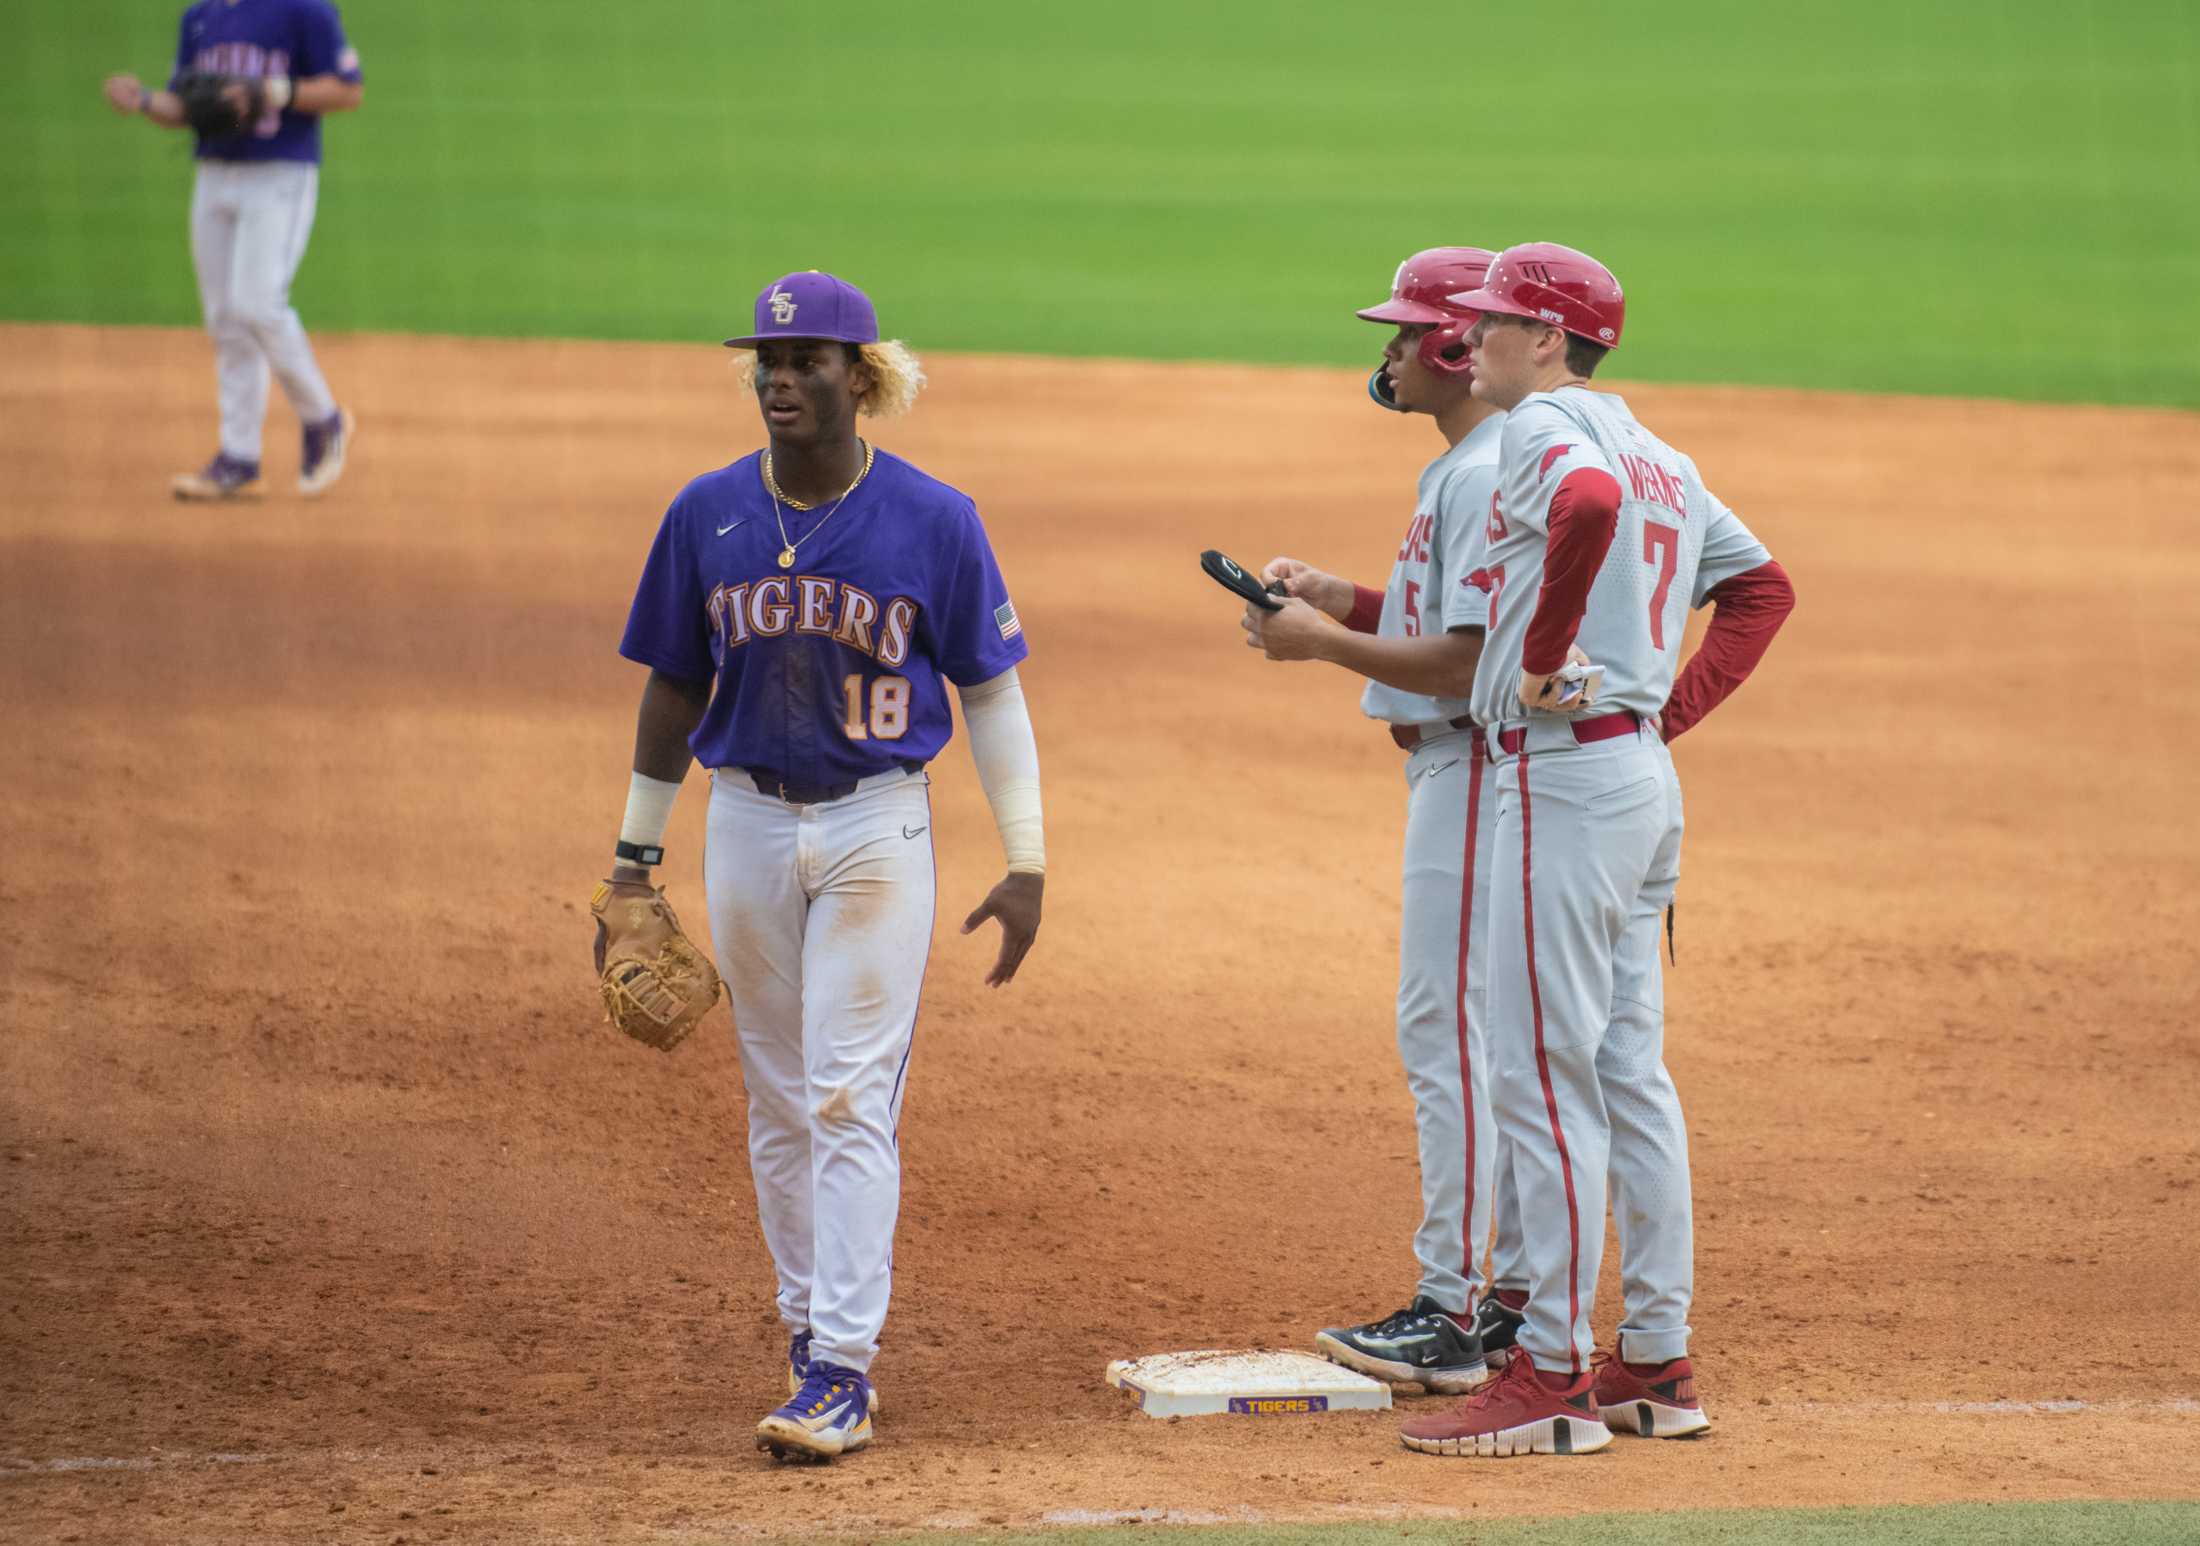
[{"left": 1243, "top": 246, "right": 1505, "bottom": 1394}]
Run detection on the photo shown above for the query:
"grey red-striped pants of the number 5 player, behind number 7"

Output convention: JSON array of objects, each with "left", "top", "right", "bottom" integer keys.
[{"left": 1397, "top": 730, "right": 1496, "bottom": 1313}]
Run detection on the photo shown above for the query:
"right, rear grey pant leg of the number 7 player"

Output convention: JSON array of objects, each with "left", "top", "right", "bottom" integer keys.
[{"left": 1597, "top": 743, "right": 1696, "bottom": 1363}]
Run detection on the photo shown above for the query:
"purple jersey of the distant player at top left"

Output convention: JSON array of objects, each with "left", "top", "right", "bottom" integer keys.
[{"left": 167, "top": 0, "right": 363, "bottom": 165}]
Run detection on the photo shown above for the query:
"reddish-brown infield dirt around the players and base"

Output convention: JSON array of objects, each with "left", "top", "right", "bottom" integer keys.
[{"left": 0, "top": 328, "right": 2200, "bottom": 1542}]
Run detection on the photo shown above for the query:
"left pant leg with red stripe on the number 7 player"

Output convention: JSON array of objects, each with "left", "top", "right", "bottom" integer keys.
[{"left": 1489, "top": 730, "right": 1668, "bottom": 1370}]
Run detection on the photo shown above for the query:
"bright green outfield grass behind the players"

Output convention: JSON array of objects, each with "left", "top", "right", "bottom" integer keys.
[{"left": 0, "top": 0, "right": 2200, "bottom": 407}]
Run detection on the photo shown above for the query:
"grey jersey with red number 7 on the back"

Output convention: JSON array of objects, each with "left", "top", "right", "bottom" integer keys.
[{"left": 1474, "top": 387, "right": 1771, "bottom": 724}]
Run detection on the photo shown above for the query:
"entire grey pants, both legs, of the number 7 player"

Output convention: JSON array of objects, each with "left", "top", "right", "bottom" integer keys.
[{"left": 1489, "top": 721, "right": 1694, "bottom": 1372}]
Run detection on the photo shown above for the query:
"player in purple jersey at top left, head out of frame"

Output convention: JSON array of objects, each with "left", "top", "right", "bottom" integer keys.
[{"left": 103, "top": 0, "right": 365, "bottom": 499}]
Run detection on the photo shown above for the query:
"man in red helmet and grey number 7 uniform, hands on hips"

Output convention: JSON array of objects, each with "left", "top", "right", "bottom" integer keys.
[{"left": 1404, "top": 242, "right": 1793, "bottom": 1456}]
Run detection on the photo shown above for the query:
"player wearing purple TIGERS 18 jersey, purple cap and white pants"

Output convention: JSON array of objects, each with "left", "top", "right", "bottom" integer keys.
[{"left": 612, "top": 270, "right": 1045, "bottom": 1460}]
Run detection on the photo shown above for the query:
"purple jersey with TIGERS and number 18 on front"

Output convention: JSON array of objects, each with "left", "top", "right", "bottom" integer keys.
[{"left": 618, "top": 451, "right": 1030, "bottom": 785}]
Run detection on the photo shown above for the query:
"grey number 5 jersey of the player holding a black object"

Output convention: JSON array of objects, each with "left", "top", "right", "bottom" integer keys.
[{"left": 1360, "top": 413, "right": 1505, "bottom": 726}]
